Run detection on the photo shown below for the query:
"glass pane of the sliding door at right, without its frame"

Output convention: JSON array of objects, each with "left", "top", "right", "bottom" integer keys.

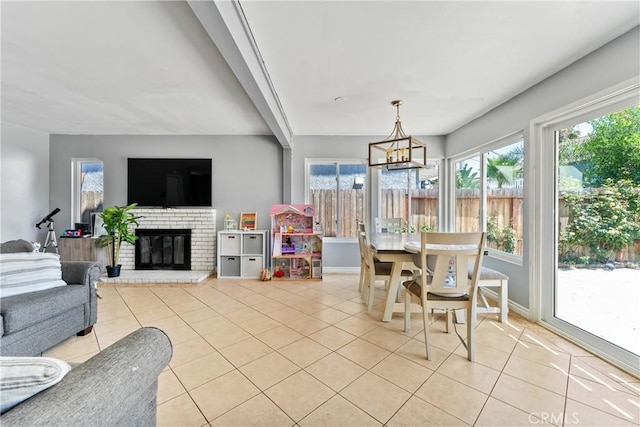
[{"left": 555, "top": 106, "right": 640, "bottom": 355}]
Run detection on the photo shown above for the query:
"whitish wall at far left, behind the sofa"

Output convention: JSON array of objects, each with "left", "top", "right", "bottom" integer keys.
[{"left": 0, "top": 123, "right": 50, "bottom": 243}]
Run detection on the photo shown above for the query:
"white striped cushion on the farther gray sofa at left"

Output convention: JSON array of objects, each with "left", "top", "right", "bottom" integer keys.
[{"left": 0, "top": 252, "right": 66, "bottom": 298}]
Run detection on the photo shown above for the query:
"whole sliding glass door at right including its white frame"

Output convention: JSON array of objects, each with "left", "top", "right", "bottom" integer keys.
[{"left": 533, "top": 97, "right": 640, "bottom": 372}]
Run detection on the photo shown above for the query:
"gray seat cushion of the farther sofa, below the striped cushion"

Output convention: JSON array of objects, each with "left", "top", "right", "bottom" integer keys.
[{"left": 0, "top": 285, "right": 88, "bottom": 335}]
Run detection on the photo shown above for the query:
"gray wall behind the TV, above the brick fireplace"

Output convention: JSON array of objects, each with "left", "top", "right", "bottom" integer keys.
[{"left": 49, "top": 135, "right": 282, "bottom": 236}]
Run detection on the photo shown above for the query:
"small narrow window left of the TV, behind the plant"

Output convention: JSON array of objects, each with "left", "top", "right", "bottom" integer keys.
[{"left": 71, "top": 159, "right": 104, "bottom": 226}]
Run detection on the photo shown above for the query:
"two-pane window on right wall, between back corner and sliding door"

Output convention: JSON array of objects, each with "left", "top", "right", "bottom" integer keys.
[{"left": 455, "top": 134, "right": 524, "bottom": 257}]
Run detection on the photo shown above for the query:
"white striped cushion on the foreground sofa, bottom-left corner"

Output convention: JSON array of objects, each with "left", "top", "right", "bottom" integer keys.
[{"left": 0, "top": 357, "right": 71, "bottom": 412}]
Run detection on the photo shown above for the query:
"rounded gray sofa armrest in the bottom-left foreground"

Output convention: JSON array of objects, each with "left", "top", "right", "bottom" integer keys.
[{"left": 2, "top": 327, "right": 172, "bottom": 426}]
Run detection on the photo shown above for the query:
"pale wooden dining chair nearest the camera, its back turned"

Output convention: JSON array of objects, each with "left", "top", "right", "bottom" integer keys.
[{"left": 402, "top": 232, "right": 486, "bottom": 361}]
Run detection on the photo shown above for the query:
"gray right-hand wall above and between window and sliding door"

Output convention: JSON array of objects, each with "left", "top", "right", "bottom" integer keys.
[{"left": 445, "top": 27, "right": 640, "bottom": 308}]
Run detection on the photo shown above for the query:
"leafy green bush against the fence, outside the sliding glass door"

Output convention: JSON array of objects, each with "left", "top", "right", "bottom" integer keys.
[{"left": 562, "top": 179, "right": 640, "bottom": 261}]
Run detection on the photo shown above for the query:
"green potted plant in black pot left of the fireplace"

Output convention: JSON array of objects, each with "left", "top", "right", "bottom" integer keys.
[{"left": 97, "top": 203, "right": 141, "bottom": 277}]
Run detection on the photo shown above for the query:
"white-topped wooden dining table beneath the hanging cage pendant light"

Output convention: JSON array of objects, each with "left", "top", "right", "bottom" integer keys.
[{"left": 369, "top": 233, "right": 420, "bottom": 322}]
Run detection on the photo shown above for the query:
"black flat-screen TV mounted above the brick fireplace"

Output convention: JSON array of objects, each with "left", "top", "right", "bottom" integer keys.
[{"left": 127, "top": 158, "right": 211, "bottom": 207}]
